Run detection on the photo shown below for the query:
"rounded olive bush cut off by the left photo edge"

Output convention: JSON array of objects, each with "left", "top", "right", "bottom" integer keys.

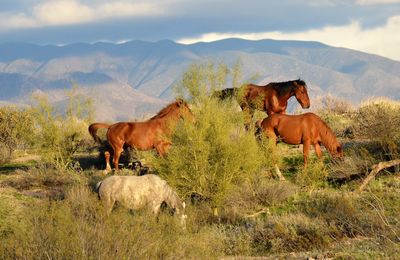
[{"left": 0, "top": 106, "right": 33, "bottom": 163}]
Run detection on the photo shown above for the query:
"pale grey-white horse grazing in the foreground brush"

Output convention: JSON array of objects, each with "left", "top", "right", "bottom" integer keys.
[{"left": 96, "top": 174, "right": 186, "bottom": 224}]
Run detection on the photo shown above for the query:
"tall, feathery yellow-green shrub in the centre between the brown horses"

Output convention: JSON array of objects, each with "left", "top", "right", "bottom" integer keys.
[{"left": 145, "top": 64, "right": 278, "bottom": 212}]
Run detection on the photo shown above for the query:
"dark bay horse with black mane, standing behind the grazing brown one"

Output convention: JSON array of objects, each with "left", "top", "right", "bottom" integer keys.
[{"left": 213, "top": 79, "right": 310, "bottom": 129}]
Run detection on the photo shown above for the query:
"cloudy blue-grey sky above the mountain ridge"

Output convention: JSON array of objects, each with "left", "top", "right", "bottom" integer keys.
[{"left": 0, "top": 0, "right": 400, "bottom": 61}]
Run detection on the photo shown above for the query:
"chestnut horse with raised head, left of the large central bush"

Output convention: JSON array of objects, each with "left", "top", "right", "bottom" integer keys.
[{"left": 88, "top": 99, "right": 194, "bottom": 171}]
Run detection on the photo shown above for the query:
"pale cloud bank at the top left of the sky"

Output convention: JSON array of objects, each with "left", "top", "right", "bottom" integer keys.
[{"left": 0, "top": 0, "right": 165, "bottom": 30}]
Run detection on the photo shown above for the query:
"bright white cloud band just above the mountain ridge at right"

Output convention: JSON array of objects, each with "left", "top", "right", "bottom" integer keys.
[{"left": 177, "top": 16, "right": 400, "bottom": 60}]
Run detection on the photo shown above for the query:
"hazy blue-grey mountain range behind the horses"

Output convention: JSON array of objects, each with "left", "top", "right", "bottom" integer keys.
[{"left": 0, "top": 39, "right": 400, "bottom": 121}]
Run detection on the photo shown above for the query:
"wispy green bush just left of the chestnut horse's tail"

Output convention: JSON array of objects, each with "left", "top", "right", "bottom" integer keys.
[{"left": 31, "top": 89, "right": 92, "bottom": 169}]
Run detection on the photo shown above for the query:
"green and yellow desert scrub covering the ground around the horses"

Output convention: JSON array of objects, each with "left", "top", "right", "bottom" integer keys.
[{"left": 0, "top": 63, "right": 400, "bottom": 259}]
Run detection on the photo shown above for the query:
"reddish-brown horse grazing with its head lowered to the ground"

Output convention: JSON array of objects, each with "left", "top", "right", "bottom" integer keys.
[{"left": 256, "top": 113, "right": 343, "bottom": 165}]
